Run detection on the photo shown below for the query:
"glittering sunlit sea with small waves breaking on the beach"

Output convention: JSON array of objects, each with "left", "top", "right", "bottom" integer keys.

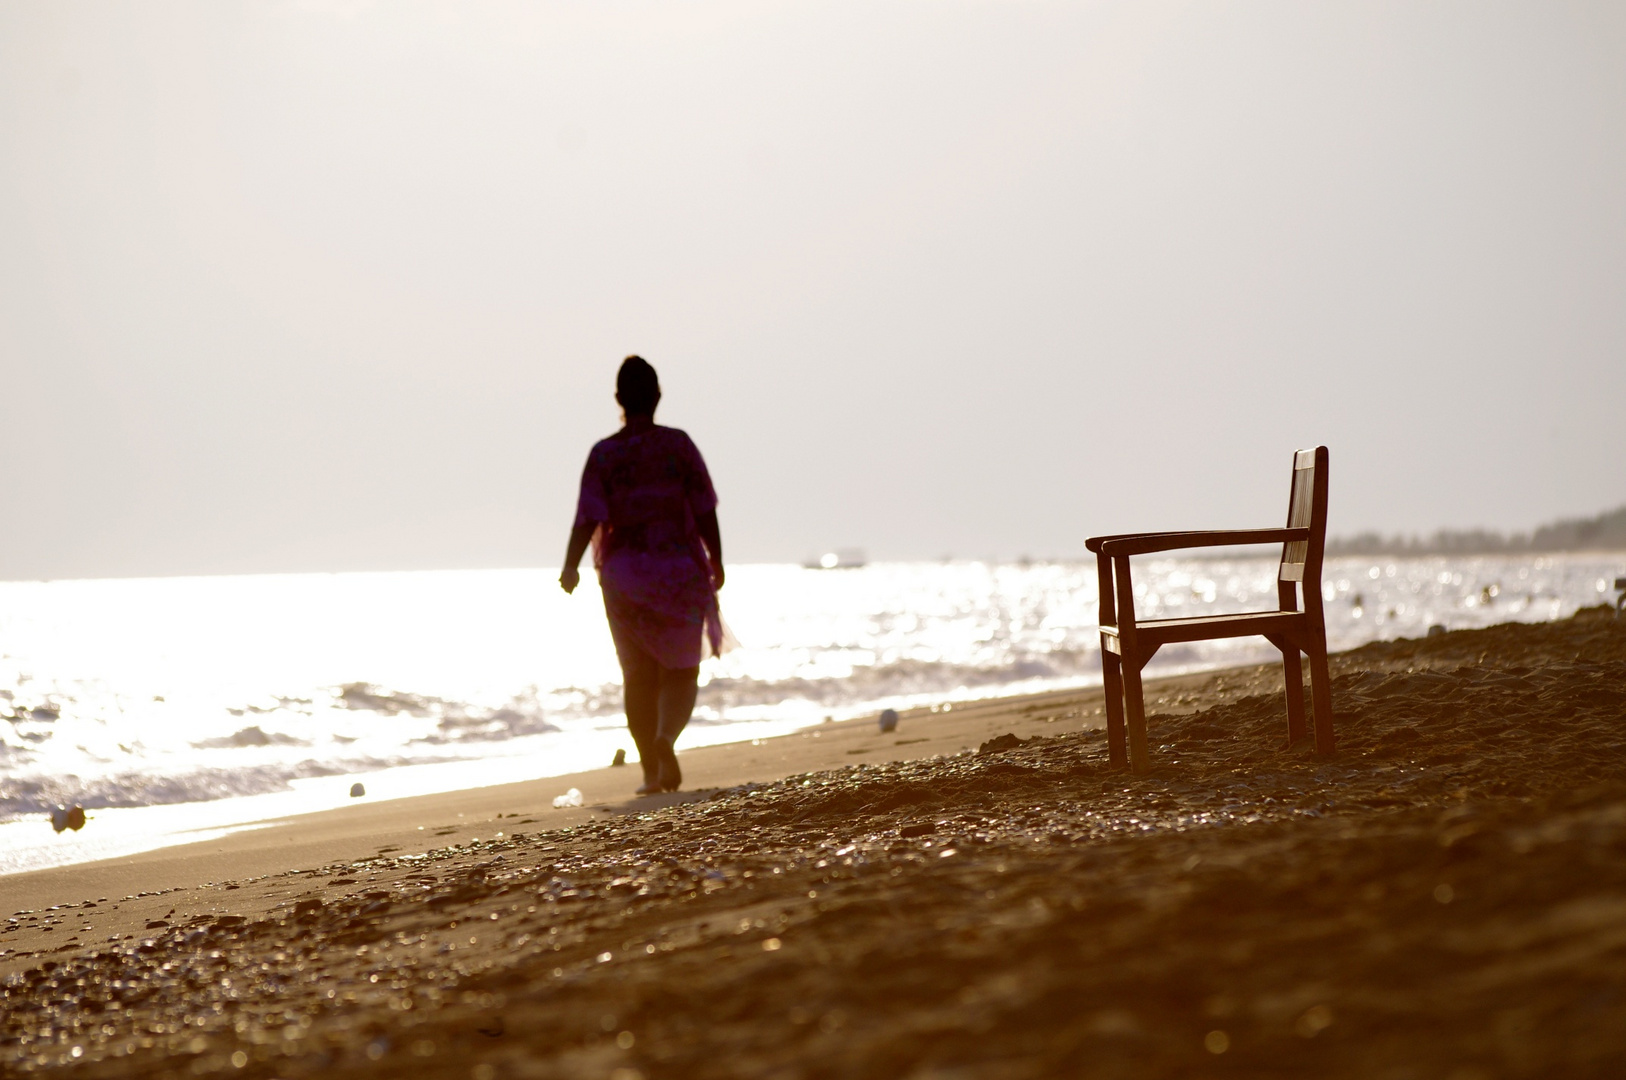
[{"left": 0, "top": 555, "right": 1626, "bottom": 872}]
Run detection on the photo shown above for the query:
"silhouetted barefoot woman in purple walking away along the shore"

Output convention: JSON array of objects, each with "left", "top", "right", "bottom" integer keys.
[{"left": 559, "top": 356, "right": 724, "bottom": 795}]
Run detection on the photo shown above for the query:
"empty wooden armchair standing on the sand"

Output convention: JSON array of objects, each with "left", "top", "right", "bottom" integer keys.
[{"left": 1085, "top": 446, "right": 1333, "bottom": 773}]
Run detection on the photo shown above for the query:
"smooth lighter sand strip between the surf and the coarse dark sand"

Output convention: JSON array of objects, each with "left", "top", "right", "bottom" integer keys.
[{"left": 0, "top": 664, "right": 1261, "bottom": 978}]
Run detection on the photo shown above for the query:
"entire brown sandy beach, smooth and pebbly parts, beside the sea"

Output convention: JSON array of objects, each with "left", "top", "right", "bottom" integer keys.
[{"left": 0, "top": 608, "right": 1626, "bottom": 1080}]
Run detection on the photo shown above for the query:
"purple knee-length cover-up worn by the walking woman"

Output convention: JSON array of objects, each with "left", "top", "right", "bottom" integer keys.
[{"left": 576, "top": 425, "right": 724, "bottom": 668}]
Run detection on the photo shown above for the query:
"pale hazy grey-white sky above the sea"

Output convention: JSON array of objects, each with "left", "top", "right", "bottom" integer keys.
[{"left": 0, "top": 0, "right": 1626, "bottom": 577}]
